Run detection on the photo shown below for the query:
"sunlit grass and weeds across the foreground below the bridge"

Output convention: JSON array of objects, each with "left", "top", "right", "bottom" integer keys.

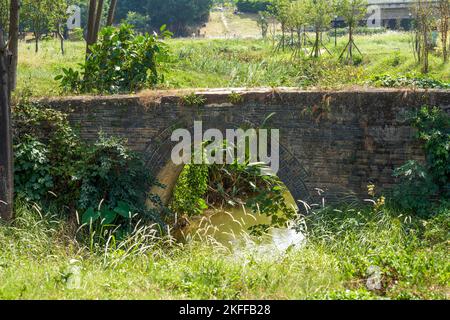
[{"left": 0, "top": 200, "right": 450, "bottom": 299}]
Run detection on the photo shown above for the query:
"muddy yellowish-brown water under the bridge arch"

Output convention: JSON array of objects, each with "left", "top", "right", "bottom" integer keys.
[{"left": 178, "top": 194, "right": 305, "bottom": 253}]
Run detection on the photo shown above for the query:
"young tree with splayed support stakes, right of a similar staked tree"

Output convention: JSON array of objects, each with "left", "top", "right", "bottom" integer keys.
[{"left": 338, "top": 0, "right": 368, "bottom": 64}]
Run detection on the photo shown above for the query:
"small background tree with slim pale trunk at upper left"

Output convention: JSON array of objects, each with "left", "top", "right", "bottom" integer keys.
[{"left": 21, "top": 0, "right": 52, "bottom": 52}]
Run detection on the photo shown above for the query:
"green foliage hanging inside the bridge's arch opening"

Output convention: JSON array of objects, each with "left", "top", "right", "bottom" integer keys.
[{"left": 171, "top": 143, "right": 297, "bottom": 235}]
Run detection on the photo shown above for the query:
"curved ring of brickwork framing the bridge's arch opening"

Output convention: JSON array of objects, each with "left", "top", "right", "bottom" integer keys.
[{"left": 144, "top": 120, "right": 312, "bottom": 208}]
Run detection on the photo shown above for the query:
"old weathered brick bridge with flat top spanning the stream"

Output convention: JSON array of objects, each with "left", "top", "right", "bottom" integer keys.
[{"left": 44, "top": 88, "right": 450, "bottom": 206}]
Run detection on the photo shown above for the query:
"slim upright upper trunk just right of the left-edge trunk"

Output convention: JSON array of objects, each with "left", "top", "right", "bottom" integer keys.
[{"left": 8, "top": 0, "right": 19, "bottom": 91}]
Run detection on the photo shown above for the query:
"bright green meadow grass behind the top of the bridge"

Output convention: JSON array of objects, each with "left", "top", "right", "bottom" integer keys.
[{"left": 14, "top": 32, "right": 450, "bottom": 96}]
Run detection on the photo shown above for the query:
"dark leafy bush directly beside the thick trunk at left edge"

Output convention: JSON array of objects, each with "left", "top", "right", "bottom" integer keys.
[{"left": 13, "top": 98, "right": 82, "bottom": 205}]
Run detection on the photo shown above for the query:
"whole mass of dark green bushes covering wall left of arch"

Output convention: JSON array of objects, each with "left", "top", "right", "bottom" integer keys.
[{"left": 13, "top": 101, "right": 163, "bottom": 236}]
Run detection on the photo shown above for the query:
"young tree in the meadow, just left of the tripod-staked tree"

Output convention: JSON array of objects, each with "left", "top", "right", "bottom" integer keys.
[{"left": 304, "top": 0, "right": 335, "bottom": 58}]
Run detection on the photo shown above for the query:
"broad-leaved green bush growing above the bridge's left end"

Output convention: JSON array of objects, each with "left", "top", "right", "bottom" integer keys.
[{"left": 55, "top": 24, "right": 169, "bottom": 93}]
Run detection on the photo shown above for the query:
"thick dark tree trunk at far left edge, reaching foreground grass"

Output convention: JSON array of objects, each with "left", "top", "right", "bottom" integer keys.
[{"left": 0, "top": 25, "right": 14, "bottom": 221}]
